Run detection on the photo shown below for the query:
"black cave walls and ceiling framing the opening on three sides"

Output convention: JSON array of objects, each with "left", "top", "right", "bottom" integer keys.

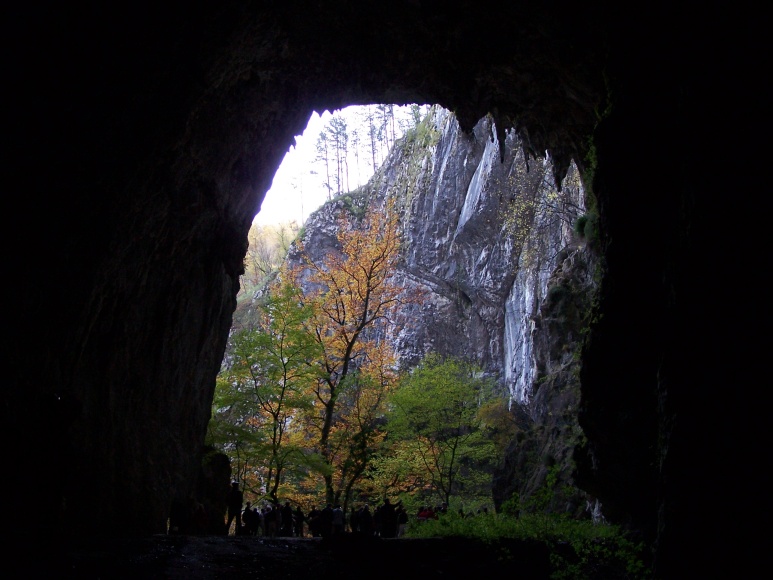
[{"left": 2, "top": 2, "right": 761, "bottom": 571}]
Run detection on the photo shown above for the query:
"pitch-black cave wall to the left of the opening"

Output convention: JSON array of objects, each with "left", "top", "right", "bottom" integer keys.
[{"left": 4, "top": 3, "right": 308, "bottom": 535}]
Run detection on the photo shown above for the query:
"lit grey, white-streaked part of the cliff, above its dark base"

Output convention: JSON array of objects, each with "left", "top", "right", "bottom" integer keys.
[{"left": 291, "top": 108, "right": 584, "bottom": 404}]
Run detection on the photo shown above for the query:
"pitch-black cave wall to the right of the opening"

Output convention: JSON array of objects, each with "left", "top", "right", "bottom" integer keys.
[{"left": 576, "top": 7, "right": 760, "bottom": 578}]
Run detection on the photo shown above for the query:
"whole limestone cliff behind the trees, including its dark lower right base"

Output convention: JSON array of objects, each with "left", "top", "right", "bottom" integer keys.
[{"left": 288, "top": 107, "right": 594, "bottom": 503}]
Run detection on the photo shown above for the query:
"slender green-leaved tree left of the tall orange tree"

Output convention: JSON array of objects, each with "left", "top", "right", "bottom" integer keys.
[{"left": 207, "top": 283, "right": 319, "bottom": 502}]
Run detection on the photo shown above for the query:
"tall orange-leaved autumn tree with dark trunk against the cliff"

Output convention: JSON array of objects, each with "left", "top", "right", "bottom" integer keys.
[{"left": 289, "top": 199, "right": 414, "bottom": 503}]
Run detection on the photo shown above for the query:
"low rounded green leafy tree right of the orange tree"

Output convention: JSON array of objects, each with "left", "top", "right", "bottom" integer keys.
[{"left": 387, "top": 354, "right": 496, "bottom": 503}]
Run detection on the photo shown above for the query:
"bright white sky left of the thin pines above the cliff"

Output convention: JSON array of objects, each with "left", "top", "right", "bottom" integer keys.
[{"left": 253, "top": 107, "right": 422, "bottom": 226}]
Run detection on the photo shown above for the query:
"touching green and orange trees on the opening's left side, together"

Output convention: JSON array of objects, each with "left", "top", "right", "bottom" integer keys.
[{"left": 212, "top": 204, "right": 426, "bottom": 505}]
